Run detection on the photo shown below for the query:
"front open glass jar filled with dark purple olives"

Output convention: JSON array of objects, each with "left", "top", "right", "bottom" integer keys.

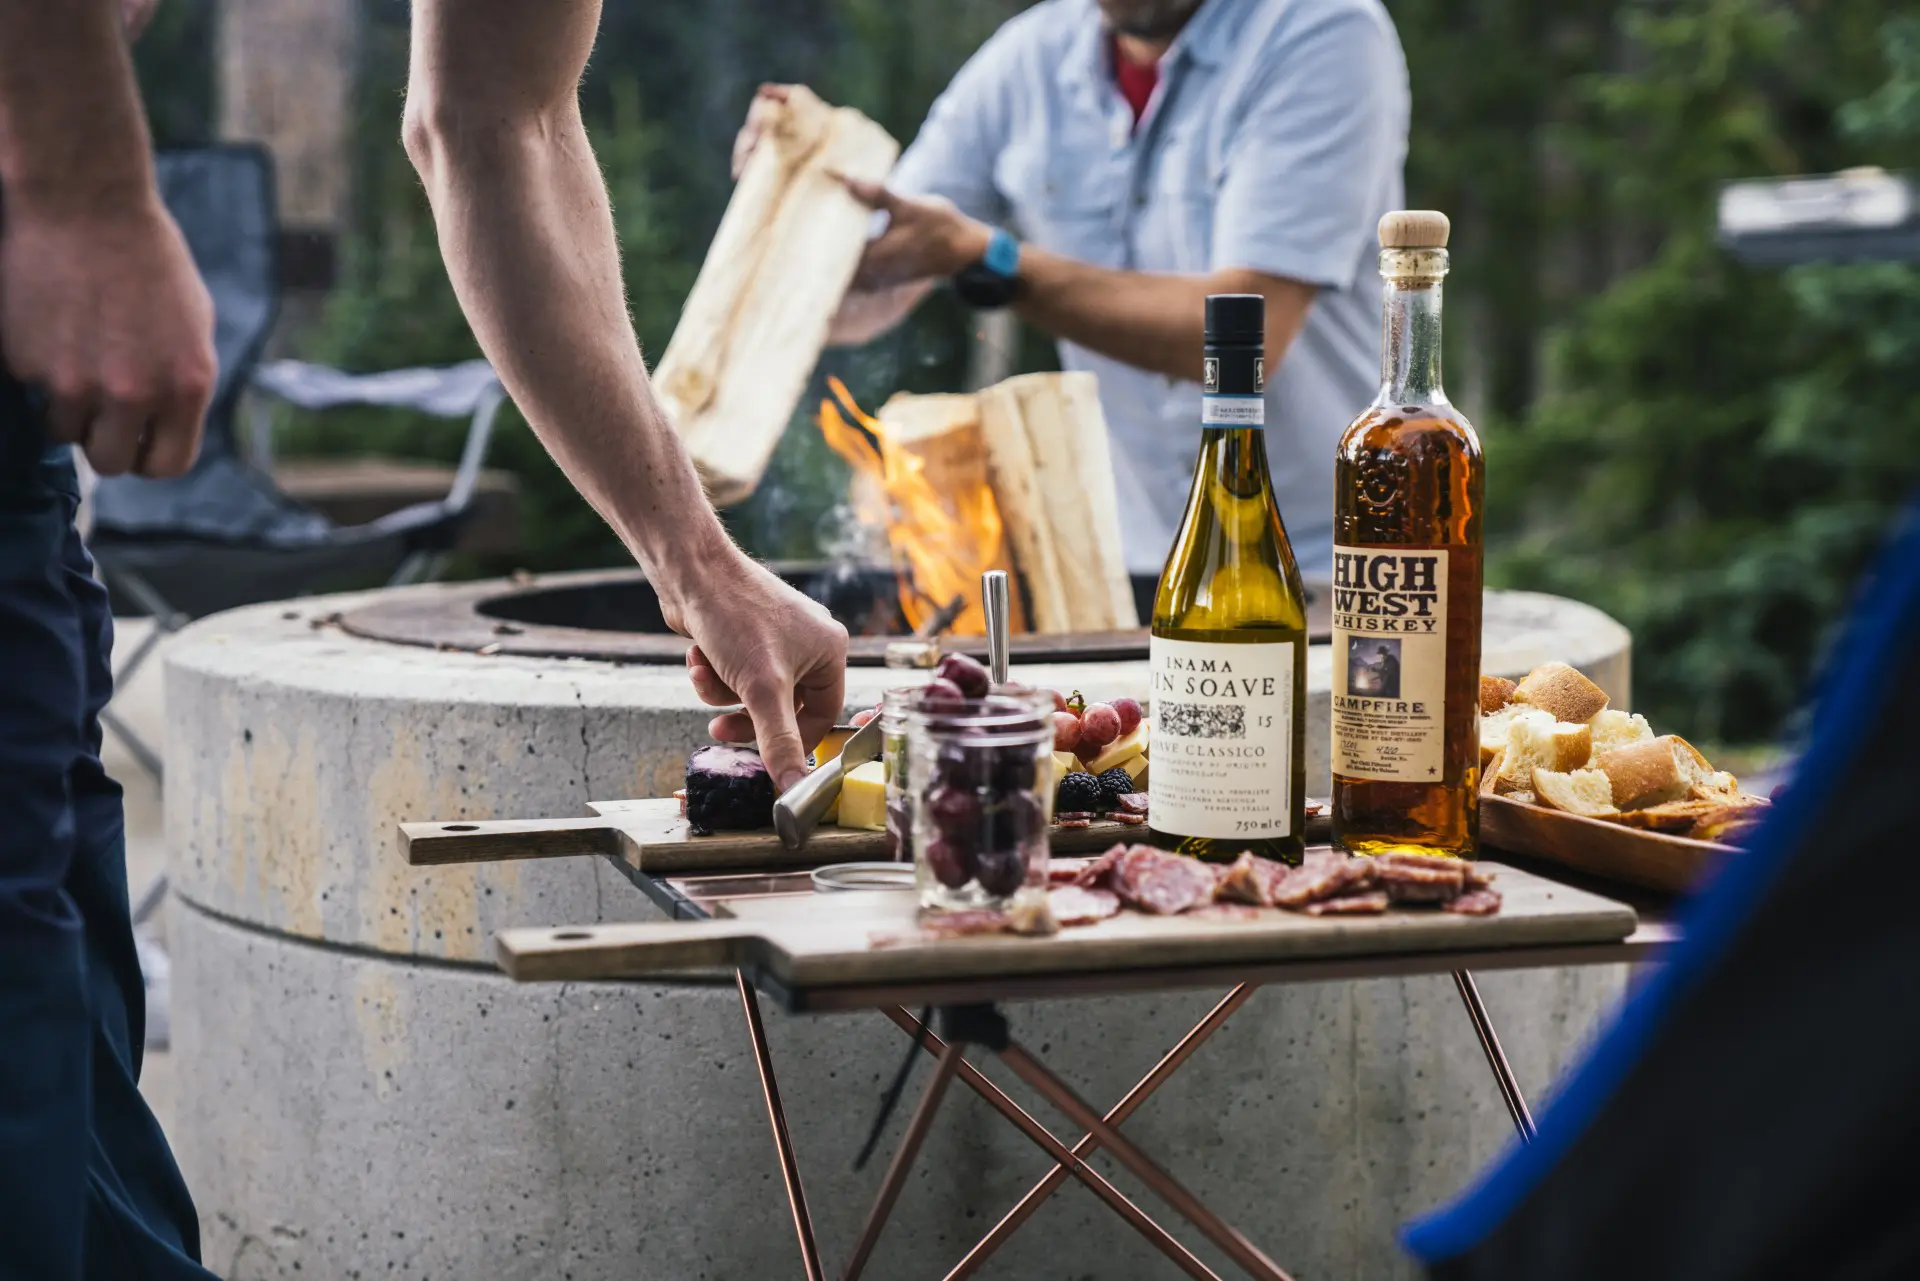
[{"left": 902, "top": 691, "right": 1054, "bottom": 910}]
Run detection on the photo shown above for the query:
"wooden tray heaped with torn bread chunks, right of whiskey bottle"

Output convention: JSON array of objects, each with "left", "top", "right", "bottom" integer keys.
[{"left": 1480, "top": 663, "right": 1768, "bottom": 893}]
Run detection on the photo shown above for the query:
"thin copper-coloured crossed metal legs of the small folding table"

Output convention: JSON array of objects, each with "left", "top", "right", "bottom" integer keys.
[{"left": 735, "top": 970, "right": 1534, "bottom": 1281}]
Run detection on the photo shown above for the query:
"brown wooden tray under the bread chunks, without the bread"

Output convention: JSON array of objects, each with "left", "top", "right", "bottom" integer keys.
[{"left": 1480, "top": 795, "right": 1740, "bottom": 893}]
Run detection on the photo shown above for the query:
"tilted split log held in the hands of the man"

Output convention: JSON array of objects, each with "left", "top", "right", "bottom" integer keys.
[{"left": 653, "top": 86, "right": 900, "bottom": 507}]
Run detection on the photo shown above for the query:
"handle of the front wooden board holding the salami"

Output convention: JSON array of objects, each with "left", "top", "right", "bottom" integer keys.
[{"left": 497, "top": 920, "right": 760, "bottom": 983}]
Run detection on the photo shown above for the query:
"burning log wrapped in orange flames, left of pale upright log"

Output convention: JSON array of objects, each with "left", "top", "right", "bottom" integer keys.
[{"left": 814, "top": 378, "right": 1025, "bottom": 636}]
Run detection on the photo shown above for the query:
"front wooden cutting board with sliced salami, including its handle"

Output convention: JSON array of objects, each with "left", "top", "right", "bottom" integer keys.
[{"left": 499, "top": 862, "right": 1636, "bottom": 987}]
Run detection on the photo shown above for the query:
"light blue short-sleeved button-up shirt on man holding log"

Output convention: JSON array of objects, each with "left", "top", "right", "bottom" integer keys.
[{"left": 889, "top": 0, "right": 1407, "bottom": 578}]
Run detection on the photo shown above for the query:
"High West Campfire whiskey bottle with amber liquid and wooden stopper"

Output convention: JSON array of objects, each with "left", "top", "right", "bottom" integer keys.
[{"left": 1332, "top": 211, "right": 1486, "bottom": 857}]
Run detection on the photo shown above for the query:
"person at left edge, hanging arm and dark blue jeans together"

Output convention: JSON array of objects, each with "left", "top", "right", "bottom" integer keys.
[{"left": 0, "top": 0, "right": 215, "bottom": 1281}]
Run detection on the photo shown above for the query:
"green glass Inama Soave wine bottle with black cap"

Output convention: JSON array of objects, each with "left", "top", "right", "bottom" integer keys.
[{"left": 1146, "top": 294, "right": 1308, "bottom": 862}]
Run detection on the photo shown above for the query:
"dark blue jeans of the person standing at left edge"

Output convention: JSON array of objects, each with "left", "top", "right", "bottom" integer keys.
[{"left": 0, "top": 375, "right": 211, "bottom": 1281}]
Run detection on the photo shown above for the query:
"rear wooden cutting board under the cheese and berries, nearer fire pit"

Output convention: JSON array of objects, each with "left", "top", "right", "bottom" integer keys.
[{"left": 399, "top": 797, "right": 1198, "bottom": 876}]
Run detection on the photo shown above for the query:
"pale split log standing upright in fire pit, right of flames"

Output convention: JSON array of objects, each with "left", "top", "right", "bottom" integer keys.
[{"left": 977, "top": 373, "right": 1140, "bottom": 632}]
